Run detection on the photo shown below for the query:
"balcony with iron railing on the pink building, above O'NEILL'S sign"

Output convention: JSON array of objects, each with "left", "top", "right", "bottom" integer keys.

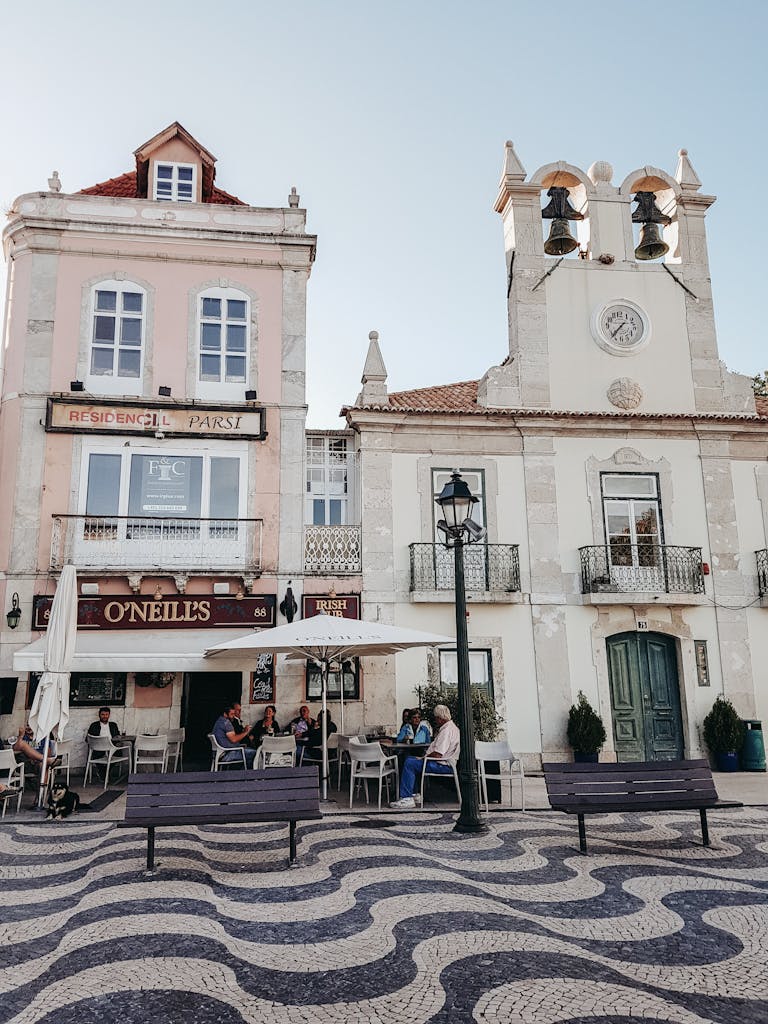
[{"left": 50, "top": 515, "right": 262, "bottom": 573}]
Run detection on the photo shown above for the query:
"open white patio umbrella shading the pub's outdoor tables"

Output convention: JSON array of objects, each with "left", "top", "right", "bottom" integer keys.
[{"left": 205, "top": 612, "right": 456, "bottom": 800}]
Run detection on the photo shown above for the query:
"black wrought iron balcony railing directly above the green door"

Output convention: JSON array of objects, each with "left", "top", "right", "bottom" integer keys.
[{"left": 579, "top": 542, "right": 703, "bottom": 594}]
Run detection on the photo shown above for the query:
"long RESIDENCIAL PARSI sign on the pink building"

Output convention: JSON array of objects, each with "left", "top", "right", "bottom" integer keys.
[{"left": 45, "top": 398, "right": 266, "bottom": 440}]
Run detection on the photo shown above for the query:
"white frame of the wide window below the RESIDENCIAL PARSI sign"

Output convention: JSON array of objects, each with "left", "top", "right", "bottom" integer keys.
[{"left": 78, "top": 438, "right": 248, "bottom": 519}]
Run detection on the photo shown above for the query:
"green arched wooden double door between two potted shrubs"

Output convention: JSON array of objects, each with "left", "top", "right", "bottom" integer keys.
[{"left": 606, "top": 633, "right": 683, "bottom": 761}]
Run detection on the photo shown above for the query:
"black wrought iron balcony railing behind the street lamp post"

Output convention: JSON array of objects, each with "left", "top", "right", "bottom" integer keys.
[{"left": 410, "top": 544, "right": 520, "bottom": 593}]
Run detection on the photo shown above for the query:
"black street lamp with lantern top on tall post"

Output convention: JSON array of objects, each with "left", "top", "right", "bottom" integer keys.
[{"left": 435, "top": 470, "right": 488, "bottom": 833}]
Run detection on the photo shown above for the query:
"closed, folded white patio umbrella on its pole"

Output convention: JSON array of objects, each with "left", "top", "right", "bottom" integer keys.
[{"left": 30, "top": 565, "right": 78, "bottom": 804}]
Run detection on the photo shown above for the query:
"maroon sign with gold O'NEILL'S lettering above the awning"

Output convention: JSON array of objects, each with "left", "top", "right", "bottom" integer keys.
[{"left": 32, "top": 594, "right": 276, "bottom": 630}]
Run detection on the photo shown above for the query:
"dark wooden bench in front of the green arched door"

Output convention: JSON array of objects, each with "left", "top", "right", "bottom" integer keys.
[{"left": 542, "top": 760, "right": 742, "bottom": 853}]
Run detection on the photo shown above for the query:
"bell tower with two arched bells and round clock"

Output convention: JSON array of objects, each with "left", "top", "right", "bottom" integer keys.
[{"left": 478, "top": 142, "right": 755, "bottom": 414}]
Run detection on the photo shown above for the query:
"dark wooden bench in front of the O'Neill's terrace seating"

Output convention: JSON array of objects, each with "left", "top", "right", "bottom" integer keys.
[{"left": 120, "top": 767, "right": 323, "bottom": 871}]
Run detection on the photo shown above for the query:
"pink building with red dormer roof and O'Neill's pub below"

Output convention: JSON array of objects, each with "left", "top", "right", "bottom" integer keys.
[{"left": 0, "top": 123, "right": 328, "bottom": 756}]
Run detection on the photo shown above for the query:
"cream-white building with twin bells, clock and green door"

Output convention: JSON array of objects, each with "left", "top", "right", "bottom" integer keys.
[{"left": 345, "top": 143, "right": 768, "bottom": 766}]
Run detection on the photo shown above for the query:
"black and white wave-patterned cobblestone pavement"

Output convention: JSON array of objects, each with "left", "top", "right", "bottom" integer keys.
[{"left": 0, "top": 808, "right": 768, "bottom": 1024}]
